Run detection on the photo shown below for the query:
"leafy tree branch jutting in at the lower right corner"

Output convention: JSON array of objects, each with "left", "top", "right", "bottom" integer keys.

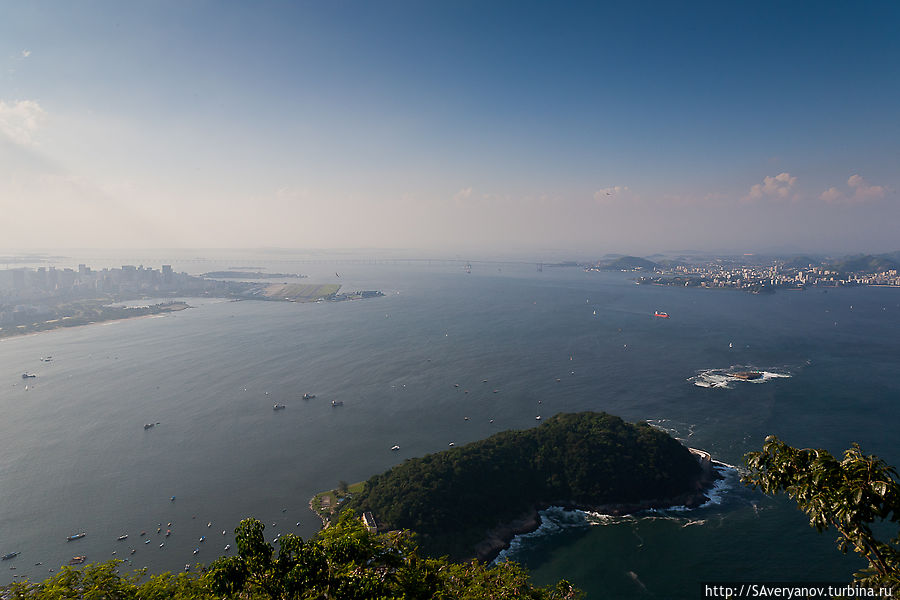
[{"left": 743, "top": 436, "right": 900, "bottom": 590}]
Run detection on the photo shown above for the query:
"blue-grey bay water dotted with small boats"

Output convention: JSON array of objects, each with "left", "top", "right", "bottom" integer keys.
[{"left": 0, "top": 261, "right": 900, "bottom": 598}]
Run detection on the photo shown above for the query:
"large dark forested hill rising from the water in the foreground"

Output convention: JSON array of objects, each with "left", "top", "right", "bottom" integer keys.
[{"left": 346, "top": 412, "right": 717, "bottom": 560}]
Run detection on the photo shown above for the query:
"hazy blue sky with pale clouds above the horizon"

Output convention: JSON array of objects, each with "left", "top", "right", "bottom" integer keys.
[{"left": 0, "top": 1, "right": 900, "bottom": 254}]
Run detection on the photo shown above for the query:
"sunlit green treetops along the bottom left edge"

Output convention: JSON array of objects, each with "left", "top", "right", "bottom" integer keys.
[{"left": 8, "top": 511, "right": 581, "bottom": 600}]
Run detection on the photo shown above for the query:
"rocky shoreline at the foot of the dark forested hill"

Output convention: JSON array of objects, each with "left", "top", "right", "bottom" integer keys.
[{"left": 474, "top": 458, "right": 726, "bottom": 563}]
